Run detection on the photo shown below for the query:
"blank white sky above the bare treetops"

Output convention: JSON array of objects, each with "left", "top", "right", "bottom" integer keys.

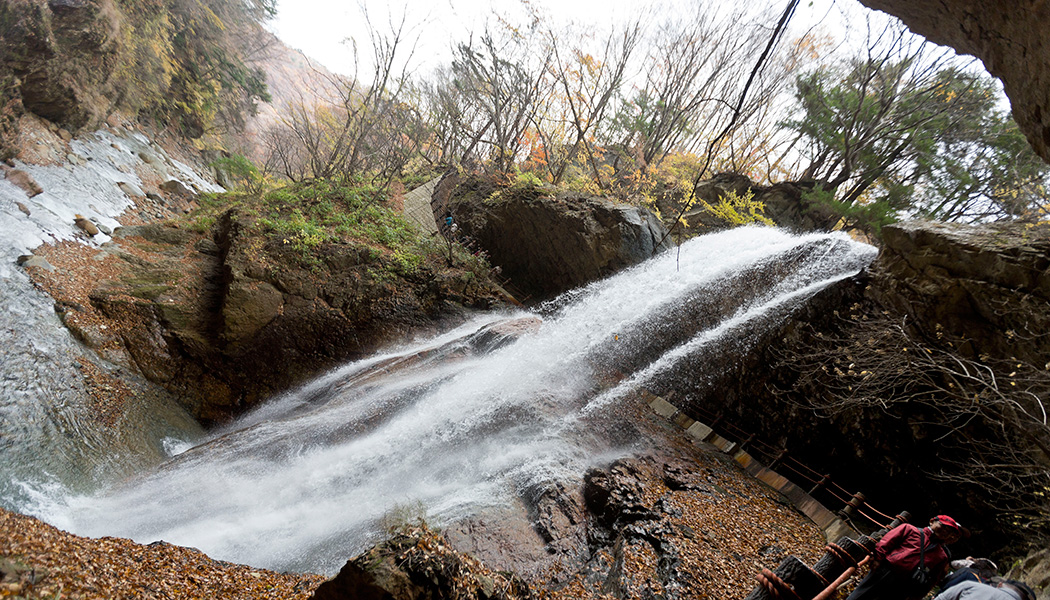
[{"left": 272, "top": 0, "right": 866, "bottom": 75}]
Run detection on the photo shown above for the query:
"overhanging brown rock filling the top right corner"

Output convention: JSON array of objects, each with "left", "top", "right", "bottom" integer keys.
[{"left": 861, "top": 0, "right": 1050, "bottom": 160}]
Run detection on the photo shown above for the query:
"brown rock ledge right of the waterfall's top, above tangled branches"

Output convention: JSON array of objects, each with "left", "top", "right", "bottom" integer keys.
[{"left": 872, "top": 222, "right": 1050, "bottom": 366}]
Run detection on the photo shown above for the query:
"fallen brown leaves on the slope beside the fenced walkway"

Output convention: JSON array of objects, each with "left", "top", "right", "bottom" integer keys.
[{"left": 531, "top": 405, "right": 825, "bottom": 600}]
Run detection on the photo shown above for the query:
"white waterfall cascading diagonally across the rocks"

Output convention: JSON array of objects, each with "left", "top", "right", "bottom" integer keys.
[{"left": 22, "top": 228, "right": 875, "bottom": 573}]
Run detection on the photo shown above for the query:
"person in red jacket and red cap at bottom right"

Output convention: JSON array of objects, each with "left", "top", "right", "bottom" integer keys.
[{"left": 846, "top": 515, "right": 962, "bottom": 600}]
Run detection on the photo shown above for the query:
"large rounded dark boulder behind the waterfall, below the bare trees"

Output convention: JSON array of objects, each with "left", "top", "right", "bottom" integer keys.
[{"left": 448, "top": 179, "right": 673, "bottom": 298}]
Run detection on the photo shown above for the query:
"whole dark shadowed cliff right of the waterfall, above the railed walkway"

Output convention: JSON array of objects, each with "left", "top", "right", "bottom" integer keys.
[{"left": 656, "top": 223, "right": 1050, "bottom": 554}]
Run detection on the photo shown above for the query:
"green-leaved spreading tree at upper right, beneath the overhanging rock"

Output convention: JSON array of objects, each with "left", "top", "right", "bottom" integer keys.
[{"left": 784, "top": 21, "right": 1047, "bottom": 230}]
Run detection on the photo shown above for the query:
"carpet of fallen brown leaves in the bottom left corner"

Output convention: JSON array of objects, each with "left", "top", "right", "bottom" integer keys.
[{"left": 0, "top": 509, "right": 324, "bottom": 600}]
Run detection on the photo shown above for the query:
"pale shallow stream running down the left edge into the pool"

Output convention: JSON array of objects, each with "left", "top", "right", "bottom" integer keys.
[{"left": 0, "top": 130, "right": 221, "bottom": 510}]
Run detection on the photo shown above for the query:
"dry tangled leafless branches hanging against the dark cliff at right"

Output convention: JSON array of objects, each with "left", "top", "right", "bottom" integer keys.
[{"left": 774, "top": 305, "right": 1050, "bottom": 532}]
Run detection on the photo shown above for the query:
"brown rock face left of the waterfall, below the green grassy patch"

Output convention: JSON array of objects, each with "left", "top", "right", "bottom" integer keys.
[{"left": 41, "top": 213, "right": 508, "bottom": 422}]
